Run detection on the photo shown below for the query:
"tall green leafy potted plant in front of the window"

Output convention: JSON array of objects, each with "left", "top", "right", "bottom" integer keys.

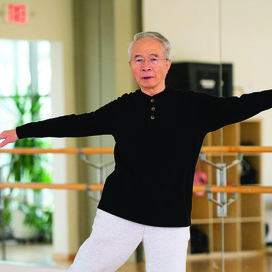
[{"left": 3, "top": 86, "right": 52, "bottom": 240}]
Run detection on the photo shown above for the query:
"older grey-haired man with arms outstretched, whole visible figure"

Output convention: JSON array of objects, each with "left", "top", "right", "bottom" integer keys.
[{"left": 0, "top": 32, "right": 272, "bottom": 272}]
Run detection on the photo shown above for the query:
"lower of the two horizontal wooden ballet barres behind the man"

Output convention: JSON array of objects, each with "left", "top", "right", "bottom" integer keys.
[{"left": 0, "top": 182, "right": 272, "bottom": 194}]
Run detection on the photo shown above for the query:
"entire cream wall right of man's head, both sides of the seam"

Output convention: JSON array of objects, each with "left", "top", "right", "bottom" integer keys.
[{"left": 143, "top": 0, "right": 272, "bottom": 202}]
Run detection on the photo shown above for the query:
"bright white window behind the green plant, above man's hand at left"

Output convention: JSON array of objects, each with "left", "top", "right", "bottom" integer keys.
[{"left": 0, "top": 40, "right": 51, "bottom": 205}]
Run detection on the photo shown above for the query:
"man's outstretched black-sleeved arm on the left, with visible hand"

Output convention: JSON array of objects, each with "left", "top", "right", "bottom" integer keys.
[{"left": 0, "top": 95, "right": 121, "bottom": 148}]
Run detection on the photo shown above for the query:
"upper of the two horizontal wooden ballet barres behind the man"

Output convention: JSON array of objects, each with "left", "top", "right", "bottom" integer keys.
[{"left": 0, "top": 146, "right": 272, "bottom": 154}]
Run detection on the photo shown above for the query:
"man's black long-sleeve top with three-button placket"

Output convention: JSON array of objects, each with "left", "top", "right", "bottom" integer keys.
[{"left": 16, "top": 87, "right": 272, "bottom": 227}]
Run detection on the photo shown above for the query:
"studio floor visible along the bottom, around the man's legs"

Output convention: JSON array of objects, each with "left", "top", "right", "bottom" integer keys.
[{"left": 0, "top": 243, "right": 272, "bottom": 272}]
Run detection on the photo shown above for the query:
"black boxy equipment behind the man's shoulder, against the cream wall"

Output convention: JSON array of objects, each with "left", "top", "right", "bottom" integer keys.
[{"left": 165, "top": 62, "right": 233, "bottom": 97}]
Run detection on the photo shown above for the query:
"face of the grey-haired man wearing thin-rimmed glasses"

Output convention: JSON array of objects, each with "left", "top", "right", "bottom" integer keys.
[{"left": 129, "top": 38, "right": 171, "bottom": 95}]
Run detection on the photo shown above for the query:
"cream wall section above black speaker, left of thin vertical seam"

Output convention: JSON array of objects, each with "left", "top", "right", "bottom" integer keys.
[{"left": 143, "top": 0, "right": 219, "bottom": 62}]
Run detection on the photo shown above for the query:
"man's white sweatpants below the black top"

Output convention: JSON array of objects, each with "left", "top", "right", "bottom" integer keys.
[{"left": 69, "top": 209, "right": 190, "bottom": 272}]
